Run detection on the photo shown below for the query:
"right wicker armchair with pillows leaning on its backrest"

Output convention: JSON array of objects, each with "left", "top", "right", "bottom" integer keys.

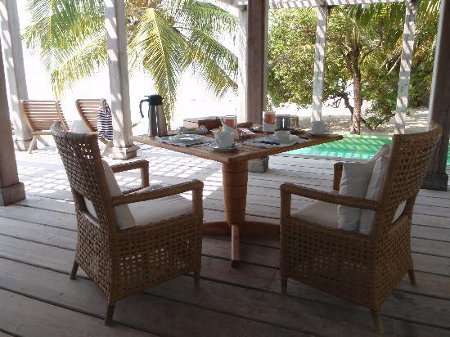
[{"left": 280, "top": 125, "right": 441, "bottom": 333}]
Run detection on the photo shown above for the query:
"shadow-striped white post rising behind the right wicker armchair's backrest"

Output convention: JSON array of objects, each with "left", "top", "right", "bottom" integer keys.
[{"left": 394, "top": 0, "right": 418, "bottom": 133}]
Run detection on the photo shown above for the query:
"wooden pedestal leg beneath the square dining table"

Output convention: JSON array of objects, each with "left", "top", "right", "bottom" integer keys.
[{"left": 222, "top": 161, "right": 248, "bottom": 267}]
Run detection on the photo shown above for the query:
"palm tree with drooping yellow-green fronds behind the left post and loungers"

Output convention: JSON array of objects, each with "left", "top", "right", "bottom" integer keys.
[{"left": 24, "top": 0, "right": 237, "bottom": 120}]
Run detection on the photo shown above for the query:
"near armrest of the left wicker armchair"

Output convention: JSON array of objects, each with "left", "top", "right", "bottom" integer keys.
[{"left": 112, "top": 180, "right": 203, "bottom": 214}]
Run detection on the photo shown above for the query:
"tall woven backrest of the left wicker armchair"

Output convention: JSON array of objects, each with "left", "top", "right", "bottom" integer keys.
[{"left": 51, "top": 123, "right": 117, "bottom": 238}]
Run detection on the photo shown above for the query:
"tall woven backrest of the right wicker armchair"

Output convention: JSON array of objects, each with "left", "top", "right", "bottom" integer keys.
[{"left": 374, "top": 124, "right": 442, "bottom": 233}]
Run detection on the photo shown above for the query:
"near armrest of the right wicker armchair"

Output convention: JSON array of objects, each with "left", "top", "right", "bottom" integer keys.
[{"left": 281, "top": 183, "right": 379, "bottom": 211}]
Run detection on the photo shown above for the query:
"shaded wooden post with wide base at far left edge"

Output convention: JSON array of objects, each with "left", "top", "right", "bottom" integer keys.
[{"left": 0, "top": 38, "right": 25, "bottom": 206}]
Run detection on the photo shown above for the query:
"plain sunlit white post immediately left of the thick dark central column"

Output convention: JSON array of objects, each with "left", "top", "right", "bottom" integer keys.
[{"left": 237, "top": 6, "right": 248, "bottom": 123}]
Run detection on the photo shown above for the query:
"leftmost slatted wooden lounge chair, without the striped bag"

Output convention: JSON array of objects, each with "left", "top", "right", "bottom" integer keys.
[{"left": 19, "top": 100, "right": 68, "bottom": 153}]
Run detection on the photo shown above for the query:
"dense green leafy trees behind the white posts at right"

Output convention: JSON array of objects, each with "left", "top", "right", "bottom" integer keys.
[{"left": 268, "top": 0, "right": 439, "bottom": 128}]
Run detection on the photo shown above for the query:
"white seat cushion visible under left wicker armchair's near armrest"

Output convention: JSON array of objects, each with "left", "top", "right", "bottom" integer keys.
[{"left": 128, "top": 195, "right": 192, "bottom": 226}]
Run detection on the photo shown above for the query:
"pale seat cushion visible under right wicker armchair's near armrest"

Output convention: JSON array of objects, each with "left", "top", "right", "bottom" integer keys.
[{"left": 291, "top": 201, "right": 338, "bottom": 228}]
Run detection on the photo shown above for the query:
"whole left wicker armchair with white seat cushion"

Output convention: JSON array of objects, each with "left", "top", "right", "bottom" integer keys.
[{"left": 51, "top": 124, "right": 203, "bottom": 324}]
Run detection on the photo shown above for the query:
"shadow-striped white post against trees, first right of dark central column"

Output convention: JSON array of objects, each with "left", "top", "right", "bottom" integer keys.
[{"left": 311, "top": 5, "right": 328, "bottom": 122}]
